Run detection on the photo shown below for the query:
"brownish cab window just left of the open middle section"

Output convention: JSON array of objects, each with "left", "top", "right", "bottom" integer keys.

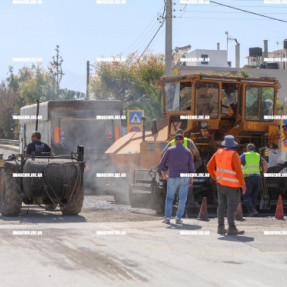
[{"left": 195, "top": 82, "right": 219, "bottom": 119}]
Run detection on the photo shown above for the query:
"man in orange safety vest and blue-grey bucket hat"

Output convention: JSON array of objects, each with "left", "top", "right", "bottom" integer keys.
[{"left": 207, "top": 135, "right": 246, "bottom": 235}]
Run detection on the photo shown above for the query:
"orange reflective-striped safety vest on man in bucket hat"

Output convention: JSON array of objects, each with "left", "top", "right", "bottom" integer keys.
[{"left": 214, "top": 149, "right": 242, "bottom": 187}]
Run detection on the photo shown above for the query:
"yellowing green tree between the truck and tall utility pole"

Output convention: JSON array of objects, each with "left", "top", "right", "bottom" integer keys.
[{"left": 89, "top": 53, "right": 164, "bottom": 128}]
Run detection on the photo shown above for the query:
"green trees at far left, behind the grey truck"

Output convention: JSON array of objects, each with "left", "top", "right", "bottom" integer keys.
[{"left": 0, "top": 46, "right": 84, "bottom": 139}]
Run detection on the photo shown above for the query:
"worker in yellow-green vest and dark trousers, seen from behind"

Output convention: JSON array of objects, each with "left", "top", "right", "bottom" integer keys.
[{"left": 240, "top": 143, "right": 268, "bottom": 217}]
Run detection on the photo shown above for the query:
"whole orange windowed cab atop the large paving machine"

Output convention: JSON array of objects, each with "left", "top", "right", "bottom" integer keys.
[{"left": 159, "top": 75, "right": 279, "bottom": 145}]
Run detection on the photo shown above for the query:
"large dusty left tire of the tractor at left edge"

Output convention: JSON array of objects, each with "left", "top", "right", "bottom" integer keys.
[{"left": 0, "top": 169, "right": 22, "bottom": 216}]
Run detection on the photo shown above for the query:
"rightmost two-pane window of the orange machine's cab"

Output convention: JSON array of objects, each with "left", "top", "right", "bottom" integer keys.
[{"left": 245, "top": 85, "right": 274, "bottom": 121}]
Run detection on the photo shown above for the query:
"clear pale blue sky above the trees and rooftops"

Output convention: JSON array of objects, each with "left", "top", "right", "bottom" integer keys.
[{"left": 0, "top": 0, "right": 287, "bottom": 92}]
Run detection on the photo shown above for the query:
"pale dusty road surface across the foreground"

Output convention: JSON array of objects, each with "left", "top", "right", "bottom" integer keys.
[{"left": 0, "top": 196, "right": 287, "bottom": 286}]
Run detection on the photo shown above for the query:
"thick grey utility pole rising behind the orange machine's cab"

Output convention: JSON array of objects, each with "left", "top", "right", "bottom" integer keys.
[{"left": 165, "top": 0, "right": 172, "bottom": 76}]
